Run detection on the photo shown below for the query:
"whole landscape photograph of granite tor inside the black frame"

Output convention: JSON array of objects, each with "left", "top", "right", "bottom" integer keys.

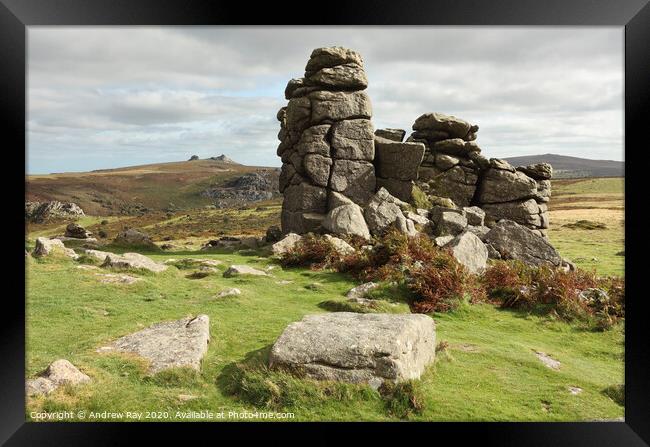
[{"left": 25, "top": 26, "right": 631, "bottom": 423}]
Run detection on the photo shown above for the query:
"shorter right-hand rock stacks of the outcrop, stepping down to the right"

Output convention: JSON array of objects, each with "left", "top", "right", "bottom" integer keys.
[{"left": 407, "top": 113, "right": 553, "bottom": 236}]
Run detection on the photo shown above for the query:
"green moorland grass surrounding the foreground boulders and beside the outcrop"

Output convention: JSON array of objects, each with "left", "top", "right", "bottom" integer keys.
[{"left": 26, "top": 179, "right": 624, "bottom": 421}]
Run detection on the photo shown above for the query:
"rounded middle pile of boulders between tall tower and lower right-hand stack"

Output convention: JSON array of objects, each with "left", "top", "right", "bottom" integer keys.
[{"left": 407, "top": 113, "right": 480, "bottom": 207}]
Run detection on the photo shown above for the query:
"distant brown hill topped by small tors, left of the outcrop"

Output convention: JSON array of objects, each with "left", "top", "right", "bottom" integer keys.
[{"left": 25, "top": 156, "right": 280, "bottom": 216}]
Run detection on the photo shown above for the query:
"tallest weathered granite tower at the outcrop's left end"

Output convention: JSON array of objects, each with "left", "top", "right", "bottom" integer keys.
[{"left": 277, "top": 47, "right": 376, "bottom": 233}]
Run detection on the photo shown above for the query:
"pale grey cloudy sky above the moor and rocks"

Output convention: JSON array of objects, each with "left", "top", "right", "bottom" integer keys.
[{"left": 27, "top": 27, "right": 623, "bottom": 174}]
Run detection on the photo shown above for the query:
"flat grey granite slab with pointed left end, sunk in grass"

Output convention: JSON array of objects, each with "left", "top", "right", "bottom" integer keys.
[{"left": 97, "top": 315, "right": 210, "bottom": 373}]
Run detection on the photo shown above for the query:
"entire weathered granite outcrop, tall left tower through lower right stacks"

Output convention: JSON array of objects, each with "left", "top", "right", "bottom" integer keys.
[{"left": 277, "top": 47, "right": 553, "bottom": 271}]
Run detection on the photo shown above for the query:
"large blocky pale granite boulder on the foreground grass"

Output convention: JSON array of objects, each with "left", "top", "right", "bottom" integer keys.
[{"left": 269, "top": 312, "right": 436, "bottom": 388}]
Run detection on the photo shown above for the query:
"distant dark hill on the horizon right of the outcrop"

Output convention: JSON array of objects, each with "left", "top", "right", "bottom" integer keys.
[{"left": 505, "top": 154, "right": 625, "bottom": 178}]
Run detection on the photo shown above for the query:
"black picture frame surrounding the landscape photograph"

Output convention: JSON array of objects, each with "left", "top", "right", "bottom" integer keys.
[{"left": 0, "top": 0, "right": 650, "bottom": 446}]
